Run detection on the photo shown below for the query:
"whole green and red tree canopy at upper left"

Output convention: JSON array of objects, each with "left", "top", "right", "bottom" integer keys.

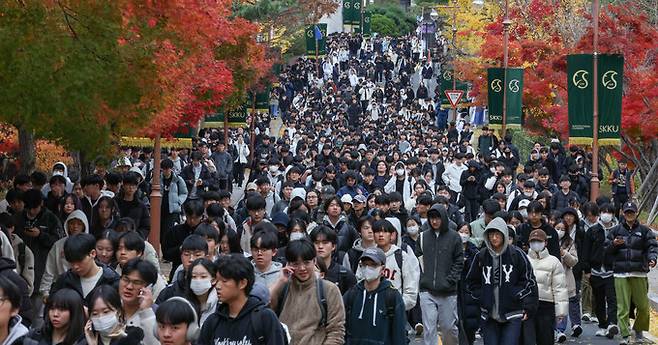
[{"left": 0, "top": 0, "right": 270, "bottom": 158}]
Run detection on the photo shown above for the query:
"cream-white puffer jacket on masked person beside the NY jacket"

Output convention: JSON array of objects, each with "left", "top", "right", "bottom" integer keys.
[{"left": 528, "top": 248, "right": 569, "bottom": 317}]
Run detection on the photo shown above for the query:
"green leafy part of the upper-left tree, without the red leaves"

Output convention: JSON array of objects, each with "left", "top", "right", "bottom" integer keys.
[{"left": 0, "top": 1, "right": 155, "bottom": 153}]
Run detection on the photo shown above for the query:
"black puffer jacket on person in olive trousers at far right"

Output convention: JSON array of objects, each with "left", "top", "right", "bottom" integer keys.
[{"left": 606, "top": 221, "right": 658, "bottom": 273}]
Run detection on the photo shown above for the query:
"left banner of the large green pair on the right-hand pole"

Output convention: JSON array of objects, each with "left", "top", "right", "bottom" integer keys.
[{"left": 567, "top": 54, "right": 594, "bottom": 145}]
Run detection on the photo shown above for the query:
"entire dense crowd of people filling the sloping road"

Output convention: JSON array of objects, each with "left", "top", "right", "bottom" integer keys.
[{"left": 0, "top": 34, "right": 658, "bottom": 345}]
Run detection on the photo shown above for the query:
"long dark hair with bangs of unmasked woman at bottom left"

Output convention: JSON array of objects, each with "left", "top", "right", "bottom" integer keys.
[{"left": 43, "top": 289, "right": 87, "bottom": 345}]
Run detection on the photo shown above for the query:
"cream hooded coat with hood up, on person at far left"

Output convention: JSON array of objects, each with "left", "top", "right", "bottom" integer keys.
[{"left": 39, "top": 210, "right": 89, "bottom": 296}]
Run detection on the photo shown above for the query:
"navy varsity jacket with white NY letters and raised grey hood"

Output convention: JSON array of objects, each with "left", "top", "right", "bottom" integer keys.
[{"left": 466, "top": 217, "right": 536, "bottom": 322}]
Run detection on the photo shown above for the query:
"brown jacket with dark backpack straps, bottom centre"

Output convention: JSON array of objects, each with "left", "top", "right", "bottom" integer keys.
[{"left": 279, "top": 275, "right": 345, "bottom": 345}]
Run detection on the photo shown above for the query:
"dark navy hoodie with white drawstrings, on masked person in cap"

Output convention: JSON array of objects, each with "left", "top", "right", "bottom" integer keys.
[{"left": 343, "top": 278, "right": 406, "bottom": 345}]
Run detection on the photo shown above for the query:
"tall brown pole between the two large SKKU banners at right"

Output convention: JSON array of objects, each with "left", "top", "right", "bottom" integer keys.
[{"left": 590, "top": 0, "right": 600, "bottom": 202}]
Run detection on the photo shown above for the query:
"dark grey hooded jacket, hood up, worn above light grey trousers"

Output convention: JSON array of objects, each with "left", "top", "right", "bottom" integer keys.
[{"left": 416, "top": 204, "right": 464, "bottom": 296}]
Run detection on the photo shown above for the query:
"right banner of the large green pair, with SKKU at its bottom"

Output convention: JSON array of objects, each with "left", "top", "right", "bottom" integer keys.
[{"left": 597, "top": 54, "right": 624, "bottom": 146}]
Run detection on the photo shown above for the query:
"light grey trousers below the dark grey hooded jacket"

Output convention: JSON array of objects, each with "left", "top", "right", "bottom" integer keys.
[{"left": 420, "top": 292, "right": 459, "bottom": 345}]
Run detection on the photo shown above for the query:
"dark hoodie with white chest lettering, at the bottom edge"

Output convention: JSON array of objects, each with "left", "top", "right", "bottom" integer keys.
[{"left": 196, "top": 297, "right": 285, "bottom": 345}]
